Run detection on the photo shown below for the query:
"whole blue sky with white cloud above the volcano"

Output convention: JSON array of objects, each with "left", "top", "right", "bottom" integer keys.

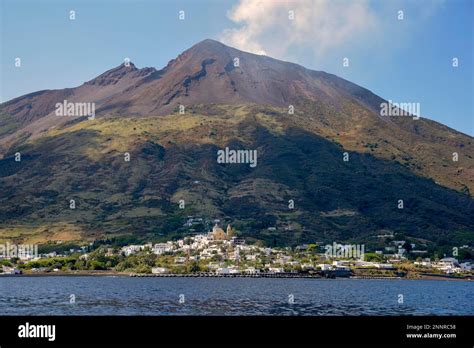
[{"left": 0, "top": 0, "right": 474, "bottom": 135}]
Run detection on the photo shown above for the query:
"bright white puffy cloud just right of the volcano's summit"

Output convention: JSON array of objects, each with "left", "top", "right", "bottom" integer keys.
[{"left": 220, "top": 0, "right": 377, "bottom": 57}]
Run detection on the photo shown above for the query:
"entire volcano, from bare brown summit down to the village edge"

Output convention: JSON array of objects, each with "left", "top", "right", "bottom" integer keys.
[{"left": 0, "top": 40, "right": 474, "bottom": 245}]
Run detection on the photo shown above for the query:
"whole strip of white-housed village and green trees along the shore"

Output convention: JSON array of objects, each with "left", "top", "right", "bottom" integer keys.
[{"left": 0, "top": 222, "right": 472, "bottom": 277}]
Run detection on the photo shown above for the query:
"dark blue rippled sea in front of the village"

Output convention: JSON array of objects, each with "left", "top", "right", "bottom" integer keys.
[{"left": 0, "top": 276, "right": 474, "bottom": 315}]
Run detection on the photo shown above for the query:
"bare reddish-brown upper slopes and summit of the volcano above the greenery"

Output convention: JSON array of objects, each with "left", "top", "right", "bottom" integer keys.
[{"left": 0, "top": 39, "right": 474, "bottom": 194}]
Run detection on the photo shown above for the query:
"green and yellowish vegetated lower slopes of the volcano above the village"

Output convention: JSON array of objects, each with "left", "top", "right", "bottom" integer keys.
[{"left": 0, "top": 104, "right": 474, "bottom": 245}]
